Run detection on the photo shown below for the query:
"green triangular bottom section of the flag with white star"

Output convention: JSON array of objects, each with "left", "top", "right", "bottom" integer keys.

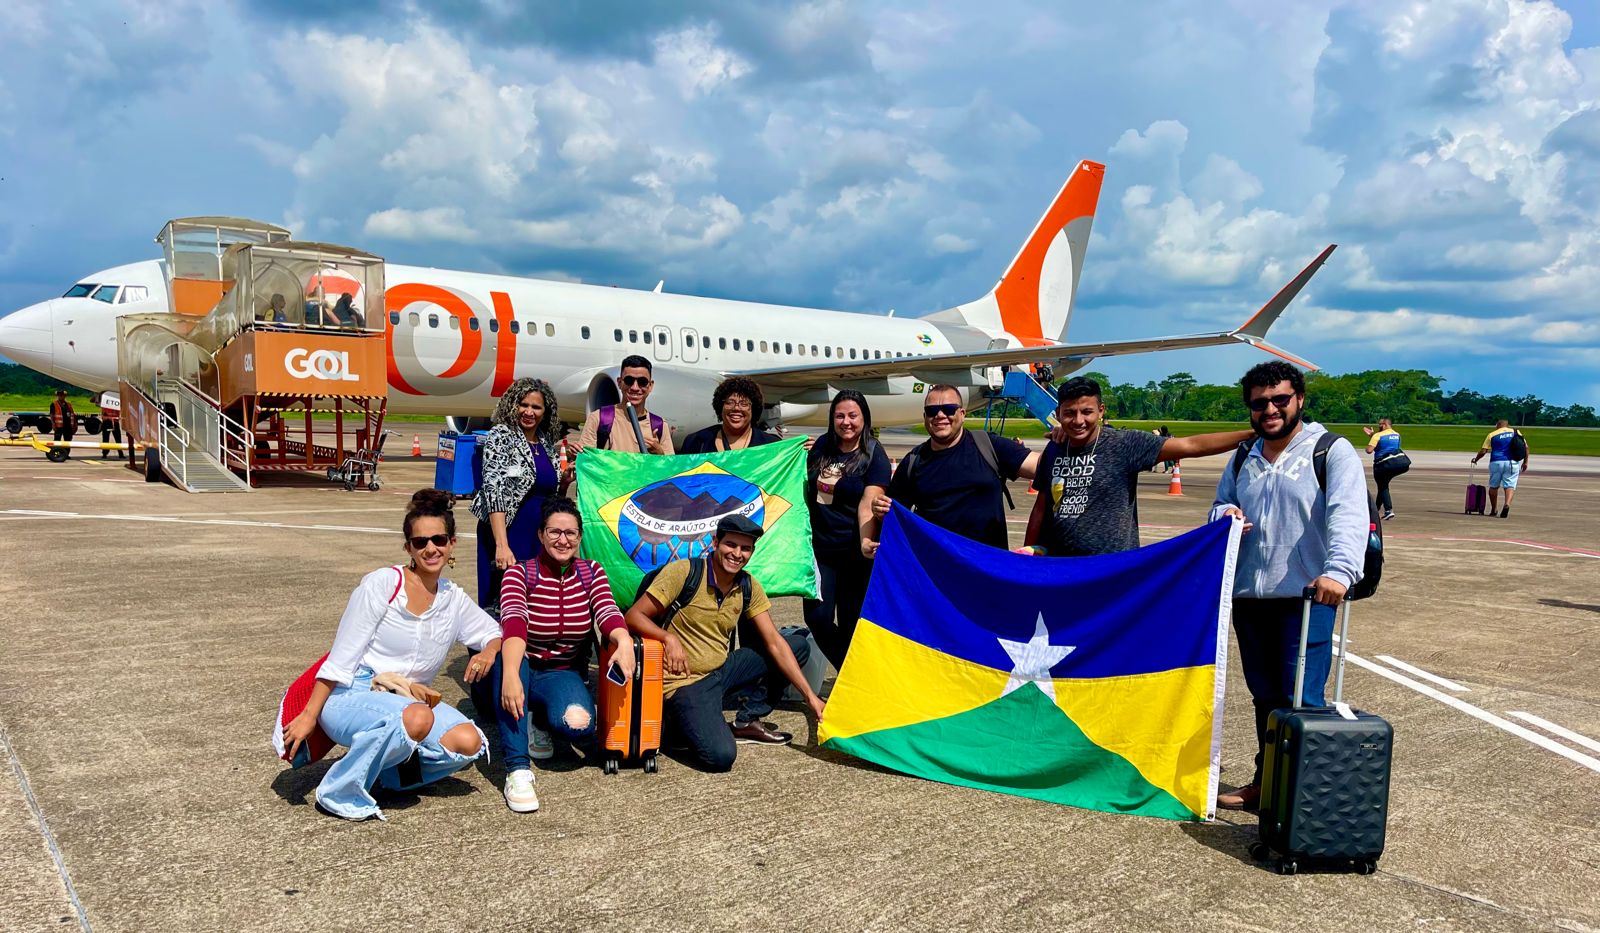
[{"left": 826, "top": 683, "right": 1197, "bottom": 819}]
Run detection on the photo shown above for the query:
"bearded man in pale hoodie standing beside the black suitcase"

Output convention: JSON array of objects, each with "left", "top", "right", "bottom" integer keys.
[{"left": 1211, "top": 360, "right": 1368, "bottom": 810}]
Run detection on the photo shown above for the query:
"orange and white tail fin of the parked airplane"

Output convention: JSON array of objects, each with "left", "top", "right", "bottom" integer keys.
[{"left": 930, "top": 160, "right": 1106, "bottom": 346}]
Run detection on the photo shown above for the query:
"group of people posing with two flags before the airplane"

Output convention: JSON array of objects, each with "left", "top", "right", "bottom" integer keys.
[{"left": 275, "top": 355, "right": 1510, "bottom": 818}]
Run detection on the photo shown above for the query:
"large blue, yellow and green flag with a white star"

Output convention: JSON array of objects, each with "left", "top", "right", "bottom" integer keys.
[{"left": 819, "top": 506, "right": 1238, "bottom": 819}]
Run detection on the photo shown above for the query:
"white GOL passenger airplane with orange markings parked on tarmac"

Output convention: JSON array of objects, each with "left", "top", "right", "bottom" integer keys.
[{"left": 0, "top": 160, "right": 1334, "bottom": 434}]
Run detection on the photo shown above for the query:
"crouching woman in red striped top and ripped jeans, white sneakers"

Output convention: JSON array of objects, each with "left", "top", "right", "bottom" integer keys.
[{"left": 490, "top": 498, "right": 634, "bottom": 813}]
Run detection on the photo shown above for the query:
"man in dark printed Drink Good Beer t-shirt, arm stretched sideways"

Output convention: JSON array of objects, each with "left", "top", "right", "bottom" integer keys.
[{"left": 1021, "top": 376, "right": 1254, "bottom": 557}]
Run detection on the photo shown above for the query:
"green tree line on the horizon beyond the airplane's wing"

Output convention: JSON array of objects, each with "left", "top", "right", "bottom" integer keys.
[{"left": 1056, "top": 370, "right": 1600, "bottom": 427}]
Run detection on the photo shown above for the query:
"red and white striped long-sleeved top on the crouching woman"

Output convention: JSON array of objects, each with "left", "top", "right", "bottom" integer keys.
[{"left": 501, "top": 554, "right": 627, "bottom": 671}]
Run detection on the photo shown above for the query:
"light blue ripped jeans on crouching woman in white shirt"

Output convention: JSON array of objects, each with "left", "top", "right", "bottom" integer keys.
[{"left": 317, "top": 667, "right": 488, "bottom": 819}]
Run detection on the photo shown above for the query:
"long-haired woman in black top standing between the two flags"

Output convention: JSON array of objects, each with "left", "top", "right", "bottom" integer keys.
[{"left": 805, "top": 389, "right": 890, "bottom": 671}]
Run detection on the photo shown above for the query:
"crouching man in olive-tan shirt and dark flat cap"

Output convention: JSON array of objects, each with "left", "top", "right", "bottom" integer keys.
[{"left": 627, "top": 515, "right": 822, "bottom": 771}]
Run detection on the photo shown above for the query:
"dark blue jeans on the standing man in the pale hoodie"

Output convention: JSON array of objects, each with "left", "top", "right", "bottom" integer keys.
[{"left": 1234, "top": 599, "right": 1336, "bottom": 784}]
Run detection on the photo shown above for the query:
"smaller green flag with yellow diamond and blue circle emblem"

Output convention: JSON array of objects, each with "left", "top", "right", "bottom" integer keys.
[{"left": 578, "top": 437, "right": 816, "bottom": 610}]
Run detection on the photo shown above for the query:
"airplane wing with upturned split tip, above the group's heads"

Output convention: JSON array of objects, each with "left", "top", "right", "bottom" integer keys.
[{"left": 723, "top": 246, "right": 1334, "bottom": 402}]
